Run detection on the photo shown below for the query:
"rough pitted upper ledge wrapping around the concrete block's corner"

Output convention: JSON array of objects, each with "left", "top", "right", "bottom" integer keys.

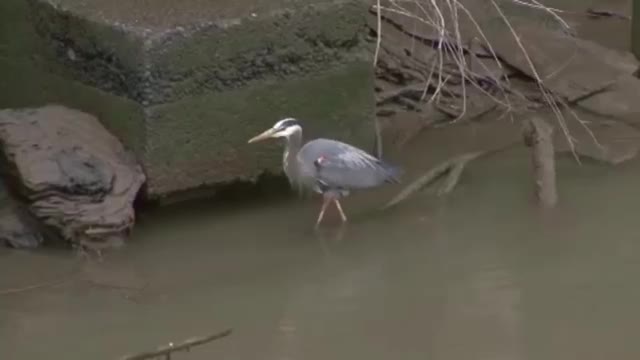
[{"left": 30, "top": 0, "right": 367, "bottom": 105}]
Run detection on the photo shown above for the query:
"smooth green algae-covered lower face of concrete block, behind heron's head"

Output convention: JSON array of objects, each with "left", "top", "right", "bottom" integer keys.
[{"left": 147, "top": 62, "right": 374, "bottom": 197}]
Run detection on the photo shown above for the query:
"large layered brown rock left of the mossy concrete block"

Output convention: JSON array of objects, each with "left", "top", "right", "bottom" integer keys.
[{"left": 0, "top": 106, "right": 145, "bottom": 248}]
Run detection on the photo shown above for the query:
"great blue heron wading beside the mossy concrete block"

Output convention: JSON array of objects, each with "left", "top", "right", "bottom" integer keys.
[{"left": 249, "top": 118, "right": 400, "bottom": 226}]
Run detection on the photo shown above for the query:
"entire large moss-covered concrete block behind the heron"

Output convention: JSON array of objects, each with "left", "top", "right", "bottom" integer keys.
[{"left": 0, "top": 0, "right": 374, "bottom": 197}]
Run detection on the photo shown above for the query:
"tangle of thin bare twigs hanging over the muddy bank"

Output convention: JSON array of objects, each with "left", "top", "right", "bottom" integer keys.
[{"left": 371, "top": 0, "right": 609, "bottom": 166}]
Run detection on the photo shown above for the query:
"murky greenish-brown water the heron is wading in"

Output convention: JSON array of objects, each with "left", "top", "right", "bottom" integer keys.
[{"left": 0, "top": 147, "right": 640, "bottom": 360}]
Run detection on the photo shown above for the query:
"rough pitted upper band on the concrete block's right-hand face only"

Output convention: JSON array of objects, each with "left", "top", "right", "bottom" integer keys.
[{"left": 145, "top": 2, "right": 368, "bottom": 103}]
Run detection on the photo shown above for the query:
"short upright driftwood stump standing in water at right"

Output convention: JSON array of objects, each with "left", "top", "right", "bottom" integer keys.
[{"left": 524, "top": 117, "right": 558, "bottom": 207}]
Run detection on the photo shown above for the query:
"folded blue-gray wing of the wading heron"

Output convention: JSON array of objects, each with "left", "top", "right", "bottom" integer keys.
[{"left": 298, "top": 139, "right": 397, "bottom": 189}]
